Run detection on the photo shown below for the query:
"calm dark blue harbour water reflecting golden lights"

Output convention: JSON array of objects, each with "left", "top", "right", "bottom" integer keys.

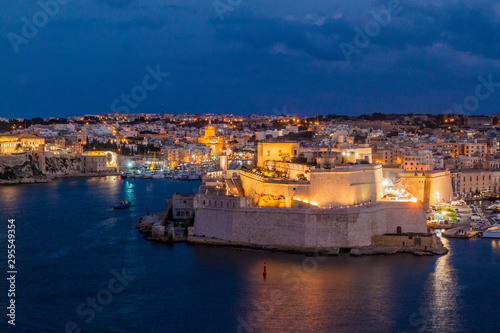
[{"left": 0, "top": 177, "right": 500, "bottom": 333}]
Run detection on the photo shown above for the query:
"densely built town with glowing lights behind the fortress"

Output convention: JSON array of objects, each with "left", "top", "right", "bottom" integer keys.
[{"left": 0, "top": 112, "right": 500, "bottom": 200}]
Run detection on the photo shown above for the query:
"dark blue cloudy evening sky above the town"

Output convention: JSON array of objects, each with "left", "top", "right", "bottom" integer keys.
[{"left": 0, "top": 0, "right": 500, "bottom": 118}]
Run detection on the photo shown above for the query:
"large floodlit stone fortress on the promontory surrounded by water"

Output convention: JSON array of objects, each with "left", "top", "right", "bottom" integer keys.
[{"left": 189, "top": 143, "right": 448, "bottom": 252}]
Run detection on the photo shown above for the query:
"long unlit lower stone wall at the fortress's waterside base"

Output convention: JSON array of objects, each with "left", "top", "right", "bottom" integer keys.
[{"left": 194, "top": 198, "right": 427, "bottom": 248}]
